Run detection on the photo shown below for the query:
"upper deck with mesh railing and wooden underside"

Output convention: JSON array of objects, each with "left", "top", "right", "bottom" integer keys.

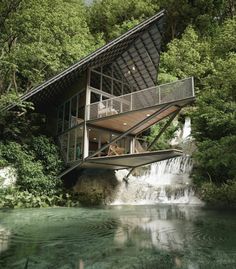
[{"left": 86, "top": 78, "right": 195, "bottom": 135}]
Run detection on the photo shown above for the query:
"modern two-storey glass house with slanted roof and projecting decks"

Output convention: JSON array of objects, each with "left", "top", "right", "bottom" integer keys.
[{"left": 4, "top": 11, "right": 194, "bottom": 176}]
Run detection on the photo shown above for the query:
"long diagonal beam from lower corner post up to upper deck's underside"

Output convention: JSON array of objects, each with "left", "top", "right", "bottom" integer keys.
[{"left": 85, "top": 104, "right": 172, "bottom": 160}]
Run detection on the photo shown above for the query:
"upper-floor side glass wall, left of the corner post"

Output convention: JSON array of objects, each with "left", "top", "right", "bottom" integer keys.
[{"left": 57, "top": 91, "right": 85, "bottom": 134}]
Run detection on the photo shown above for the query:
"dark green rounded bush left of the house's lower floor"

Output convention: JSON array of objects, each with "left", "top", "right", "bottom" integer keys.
[{"left": 0, "top": 137, "right": 62, "bottom": 195}]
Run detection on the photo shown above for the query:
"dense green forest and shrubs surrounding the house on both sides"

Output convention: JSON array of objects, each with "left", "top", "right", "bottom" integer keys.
[{"left": 0, "top": 0, "right": 236, "bottom": 207}]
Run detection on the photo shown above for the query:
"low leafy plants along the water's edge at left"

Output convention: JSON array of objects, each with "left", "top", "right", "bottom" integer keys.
[{"left": 0, "top": 188, "right": 79, "bottom": 208}]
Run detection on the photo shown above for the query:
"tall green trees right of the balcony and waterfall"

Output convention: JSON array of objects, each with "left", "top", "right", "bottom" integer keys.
[{"left": 161, "top": 14, "right": 236, "bottom": 201}]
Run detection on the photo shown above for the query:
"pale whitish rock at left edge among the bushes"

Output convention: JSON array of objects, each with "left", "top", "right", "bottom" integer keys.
[{"left": 0, "top": 166, "right": 17, "bottom": 188}]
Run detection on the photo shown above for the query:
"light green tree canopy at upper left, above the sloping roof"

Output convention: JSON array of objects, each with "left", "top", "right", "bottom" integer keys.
[{"left": 0, "top": 0, "right": 102, "bottom": 95}]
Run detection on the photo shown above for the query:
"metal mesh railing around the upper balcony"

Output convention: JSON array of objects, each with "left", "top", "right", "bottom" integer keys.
[{"left": 86, "top": 77, "right": 194, "bottom": 120}]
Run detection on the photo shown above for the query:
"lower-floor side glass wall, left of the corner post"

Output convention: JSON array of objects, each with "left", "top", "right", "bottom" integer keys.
[{"left": 59, "top": 125, "right": 83, "bottom": 163}]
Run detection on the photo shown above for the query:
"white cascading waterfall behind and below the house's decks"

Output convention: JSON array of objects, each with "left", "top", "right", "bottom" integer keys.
[{"left": 112, "top": 118, "right": 202, "bottom": 205}]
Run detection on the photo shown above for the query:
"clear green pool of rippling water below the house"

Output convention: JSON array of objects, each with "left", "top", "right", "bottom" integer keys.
[{"left": 0, "top": 205, "right": 236, "bottom": 269}]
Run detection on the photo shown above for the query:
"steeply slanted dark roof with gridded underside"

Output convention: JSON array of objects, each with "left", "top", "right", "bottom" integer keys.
[{"left": 3, "top": 11, "right": 164, "bottom": 109}]
